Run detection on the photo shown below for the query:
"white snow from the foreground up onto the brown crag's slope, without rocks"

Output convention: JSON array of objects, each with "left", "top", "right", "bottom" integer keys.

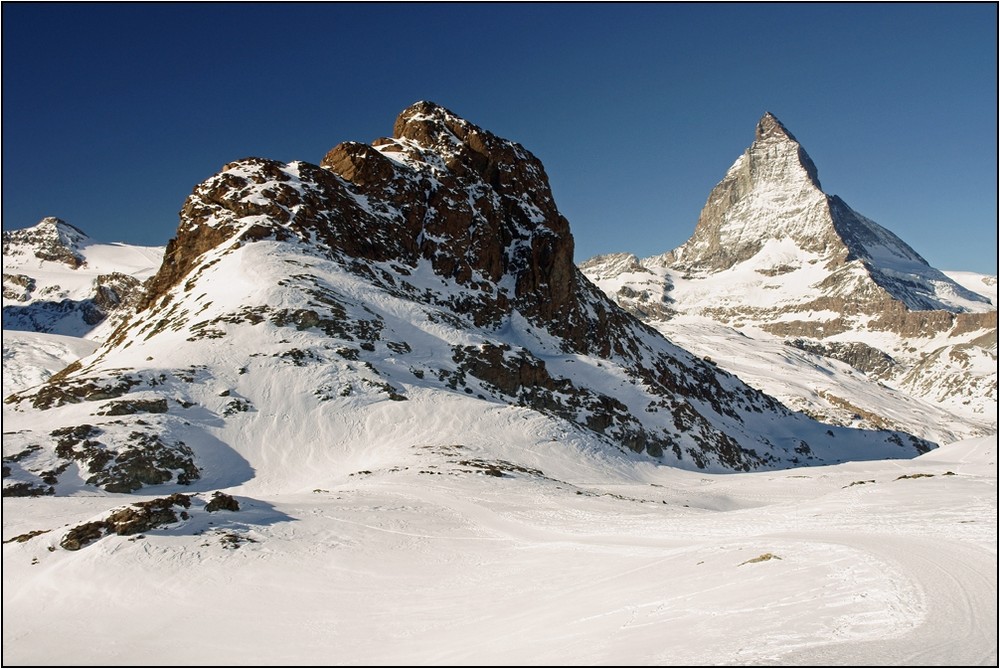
[{"left": 3, "top": 231, "right": 996, "bottom": 665}]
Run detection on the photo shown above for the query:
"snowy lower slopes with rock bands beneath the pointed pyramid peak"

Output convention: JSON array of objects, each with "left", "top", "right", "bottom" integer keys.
[{"left": 581, "top": 253, "right": 997, "bottom": 441}]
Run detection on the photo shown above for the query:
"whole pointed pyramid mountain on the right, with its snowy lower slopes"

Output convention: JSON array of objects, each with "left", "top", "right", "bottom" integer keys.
[{"left": 581, "top": 114, "right": 997, "bottom": 437}]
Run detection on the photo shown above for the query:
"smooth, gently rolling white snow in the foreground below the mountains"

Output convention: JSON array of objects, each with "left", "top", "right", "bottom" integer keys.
[{"left": 3, "top": 434, "right": 997, "bottom": 666}]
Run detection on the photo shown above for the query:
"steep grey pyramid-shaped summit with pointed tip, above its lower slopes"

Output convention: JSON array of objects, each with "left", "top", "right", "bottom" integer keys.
[{"left": 663, "top": 112, "right": 989, "bottom": 312}]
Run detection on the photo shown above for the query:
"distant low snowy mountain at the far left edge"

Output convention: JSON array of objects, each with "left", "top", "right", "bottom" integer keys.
[{"left": 3, "top": 217, "right": 163, "bottom": 341}]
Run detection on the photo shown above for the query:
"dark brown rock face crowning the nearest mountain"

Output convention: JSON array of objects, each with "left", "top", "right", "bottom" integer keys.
[{"left": 139, "top": 102, "right": 615, "bottom": 351}]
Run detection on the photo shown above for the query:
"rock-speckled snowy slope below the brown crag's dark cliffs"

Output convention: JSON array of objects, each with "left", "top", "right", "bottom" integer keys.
[{"left": 4, "top": 235, "right": 927, "bottom": 494}]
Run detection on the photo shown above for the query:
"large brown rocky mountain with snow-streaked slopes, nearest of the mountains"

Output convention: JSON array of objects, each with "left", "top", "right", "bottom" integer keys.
[{"left": 4, "top": 103, "right": 931, "bottom": 494}]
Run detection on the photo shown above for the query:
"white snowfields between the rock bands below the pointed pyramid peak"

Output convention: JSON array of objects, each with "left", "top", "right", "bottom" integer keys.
[{"left": 581, "top": 253, "right": 997, "bottom": 442}]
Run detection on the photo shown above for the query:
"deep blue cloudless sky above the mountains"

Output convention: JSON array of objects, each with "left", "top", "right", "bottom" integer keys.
[{"left": 2, "top": 2, "right": 998, "bottom": 274}]
